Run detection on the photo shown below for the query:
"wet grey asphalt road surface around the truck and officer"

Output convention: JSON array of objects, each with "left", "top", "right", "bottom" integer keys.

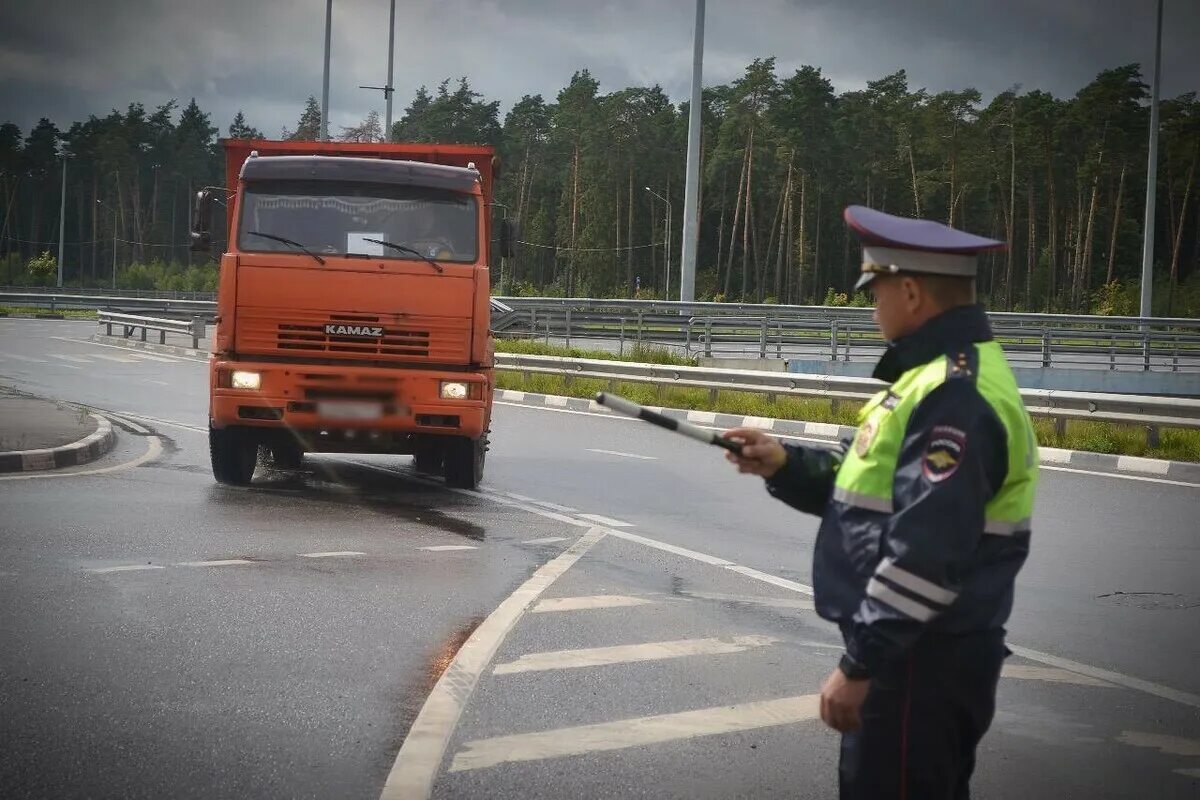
[{"left": 0, "top": 320, "right": 1200, "bottom": 798}]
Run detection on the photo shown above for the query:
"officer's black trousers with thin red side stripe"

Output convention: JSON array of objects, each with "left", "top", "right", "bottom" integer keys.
[{"left": 838, "top": 630, "right": 1008, "bottom": 800}]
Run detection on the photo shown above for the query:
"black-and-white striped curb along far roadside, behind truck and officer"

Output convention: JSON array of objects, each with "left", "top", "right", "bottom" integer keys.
[{"left": 91, "top": 333, "right": 1200, "bottom": 483}]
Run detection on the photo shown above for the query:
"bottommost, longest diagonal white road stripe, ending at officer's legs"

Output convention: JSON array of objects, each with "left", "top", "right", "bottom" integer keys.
[{"left": 449, "top": 694, "right": 821, "bottom": 772}]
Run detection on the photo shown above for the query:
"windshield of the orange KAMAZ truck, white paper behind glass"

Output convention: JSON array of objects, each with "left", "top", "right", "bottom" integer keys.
[{"left": 238, "top": 180, "right": 479, "bottom": 263}]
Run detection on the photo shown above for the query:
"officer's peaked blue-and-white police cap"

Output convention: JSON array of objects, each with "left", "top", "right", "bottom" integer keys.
[{"left": 842, "top": 205, "right": 1007, "bottom": 291}]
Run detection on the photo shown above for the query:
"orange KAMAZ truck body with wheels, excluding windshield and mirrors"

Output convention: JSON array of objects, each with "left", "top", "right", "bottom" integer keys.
[{"left": 209, "top": 139, "right": 497, "bottom": 487}]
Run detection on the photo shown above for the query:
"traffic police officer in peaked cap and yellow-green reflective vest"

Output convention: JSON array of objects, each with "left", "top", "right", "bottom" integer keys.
[{"left": 727, "top": 206, "right": 1037, "bottom": 800}]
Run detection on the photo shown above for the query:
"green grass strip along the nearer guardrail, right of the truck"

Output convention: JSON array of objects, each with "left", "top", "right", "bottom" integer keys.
[{"left": 496, "top": 339, "right": 1200, "bottom": 462}]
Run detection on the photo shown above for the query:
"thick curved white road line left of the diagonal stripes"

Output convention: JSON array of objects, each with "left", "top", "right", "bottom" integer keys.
[{"left": 379, "top": 527, "right": 607, "bottom": 800}]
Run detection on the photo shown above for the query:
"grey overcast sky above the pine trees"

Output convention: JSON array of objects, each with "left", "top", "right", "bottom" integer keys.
[{"left": 0, "top": 0, "right": 1200, "bottom": 137}]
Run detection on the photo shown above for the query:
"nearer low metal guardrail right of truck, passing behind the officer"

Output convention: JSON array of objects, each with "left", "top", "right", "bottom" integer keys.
[{"left": 496, "top": 353, "right": 1200, "bottom": 440}]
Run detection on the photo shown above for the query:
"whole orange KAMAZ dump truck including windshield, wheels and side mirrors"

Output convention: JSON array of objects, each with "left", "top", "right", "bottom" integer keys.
[{"left": 192, "top": 139, "right": 511, "bottom": 488}]
